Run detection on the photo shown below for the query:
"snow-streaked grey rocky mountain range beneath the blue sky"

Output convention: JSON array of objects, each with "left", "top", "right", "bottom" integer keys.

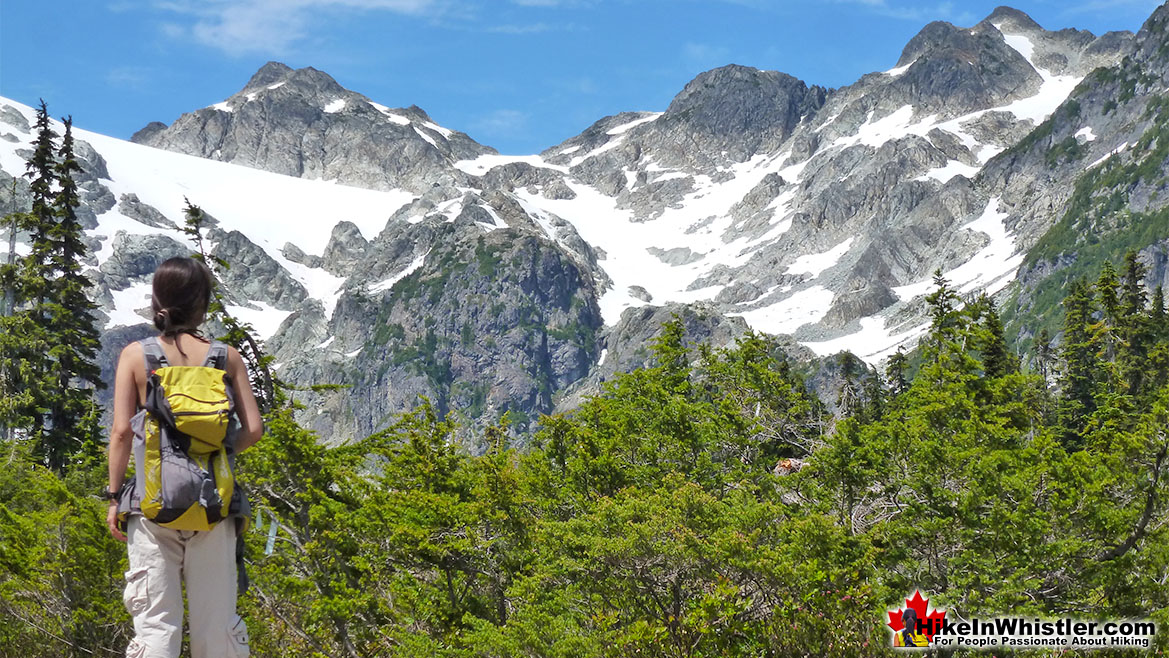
[{"left": 0, "top": 7, "right": 1169, "bottom": 439}]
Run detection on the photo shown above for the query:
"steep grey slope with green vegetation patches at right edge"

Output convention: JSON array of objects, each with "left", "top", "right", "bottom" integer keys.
[{"left": 984, "top": 1, "right": 1169, "bottom": 334}]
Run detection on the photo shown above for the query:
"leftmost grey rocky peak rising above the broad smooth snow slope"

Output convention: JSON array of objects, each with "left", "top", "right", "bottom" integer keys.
[{"left": 133, "top": 62, "right": 494, "bottom": 192}]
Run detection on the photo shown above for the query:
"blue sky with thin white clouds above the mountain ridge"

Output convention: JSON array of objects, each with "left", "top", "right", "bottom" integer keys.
[{"left": 0, "top": 0, "right": 1160, "bottom": 153}]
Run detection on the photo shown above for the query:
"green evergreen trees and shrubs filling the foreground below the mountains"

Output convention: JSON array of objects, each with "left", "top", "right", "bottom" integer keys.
[{"left": 0, "top": 106, "right": 1169, "bottom": 658}]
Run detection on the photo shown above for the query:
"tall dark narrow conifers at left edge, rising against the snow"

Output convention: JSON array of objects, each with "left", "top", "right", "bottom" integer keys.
[{"left": 0, "top": 102, "right": 102, "bottom": 472}]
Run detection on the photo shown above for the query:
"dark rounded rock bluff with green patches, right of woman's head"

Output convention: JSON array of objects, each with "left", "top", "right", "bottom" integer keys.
[{"left": 279, "top": 222, "right": 601, "bottom": 446}]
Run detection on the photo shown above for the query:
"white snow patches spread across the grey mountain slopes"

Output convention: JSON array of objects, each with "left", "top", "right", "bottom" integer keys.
[{"left": 0, "top": 20, "right": 1075, "bottom": 363}]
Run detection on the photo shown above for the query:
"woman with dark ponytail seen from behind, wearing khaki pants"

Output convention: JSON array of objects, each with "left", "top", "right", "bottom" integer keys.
[{"left": 105, "top": 258, "right": 263, "bottom": 658}]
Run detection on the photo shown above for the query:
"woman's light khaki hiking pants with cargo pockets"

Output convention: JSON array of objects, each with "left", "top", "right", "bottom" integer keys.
[{"left": 124, "top": 515, "right": 249, "bottom": 658}]
